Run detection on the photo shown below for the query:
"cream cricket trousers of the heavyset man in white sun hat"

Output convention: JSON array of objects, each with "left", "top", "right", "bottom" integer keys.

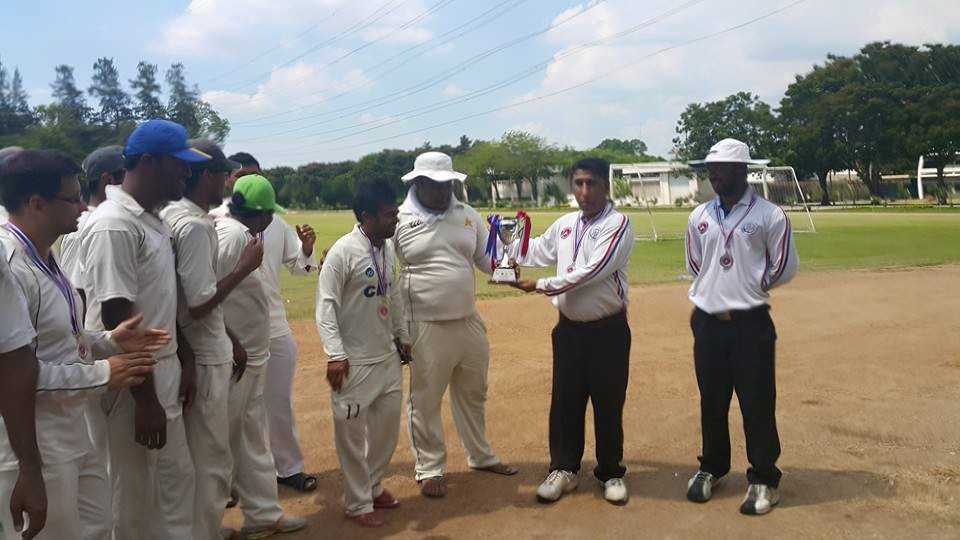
[{"left": 408, "top": 314, "right": 500, "bottom": 481}]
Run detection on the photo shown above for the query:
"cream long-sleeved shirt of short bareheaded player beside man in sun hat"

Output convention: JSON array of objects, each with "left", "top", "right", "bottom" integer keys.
[{"left": 316, "top": 225, "right": 410, "bottom": 365}]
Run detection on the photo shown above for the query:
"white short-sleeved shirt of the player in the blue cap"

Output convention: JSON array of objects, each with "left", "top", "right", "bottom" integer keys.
[{"left": 80, "top": 186, "right": 182, "bottom": 418}]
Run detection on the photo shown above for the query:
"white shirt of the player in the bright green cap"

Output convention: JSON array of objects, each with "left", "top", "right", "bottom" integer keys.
[{"left": 215, "top": 215, "right": 270, "bottom": 366}]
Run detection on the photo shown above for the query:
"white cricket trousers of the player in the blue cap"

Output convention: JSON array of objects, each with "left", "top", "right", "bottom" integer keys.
[{"left": 107, "top": 357, "right": 196, "bottom": 540}]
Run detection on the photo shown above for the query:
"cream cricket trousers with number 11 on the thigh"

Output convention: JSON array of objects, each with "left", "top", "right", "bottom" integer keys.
[{"left": 330, "top": 355, "right": 403, "bottom": 516}]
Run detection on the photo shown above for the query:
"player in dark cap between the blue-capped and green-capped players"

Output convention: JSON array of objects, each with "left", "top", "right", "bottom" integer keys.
[{"left": 160, "top": 140, "right": 263, "bottom": 540}]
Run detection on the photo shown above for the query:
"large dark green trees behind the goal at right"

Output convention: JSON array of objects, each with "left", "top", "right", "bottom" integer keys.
[{"left": 673, "top": 42, "right": 960, "bottom": 204}]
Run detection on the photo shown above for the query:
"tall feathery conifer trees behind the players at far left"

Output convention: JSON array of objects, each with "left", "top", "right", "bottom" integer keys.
[{"left": 0, "top": 57, "right": 230, "bottom": 160}]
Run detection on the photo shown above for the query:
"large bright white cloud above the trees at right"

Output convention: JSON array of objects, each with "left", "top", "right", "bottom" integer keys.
[{"left": 498, "top": 0, "right": 960, "bottom": 156}]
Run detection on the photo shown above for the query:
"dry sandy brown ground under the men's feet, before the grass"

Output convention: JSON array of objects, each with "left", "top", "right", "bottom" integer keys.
[{"left": 227, "top": 266, "right": 960, "bottom": 540}]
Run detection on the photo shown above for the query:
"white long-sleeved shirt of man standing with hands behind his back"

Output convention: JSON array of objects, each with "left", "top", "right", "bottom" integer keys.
[{"left": 686, "top": 188, "right": 800, "bottom": 313}]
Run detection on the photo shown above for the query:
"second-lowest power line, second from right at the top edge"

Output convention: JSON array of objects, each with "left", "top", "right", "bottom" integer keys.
[{"left": 229, "top": 0, "right": 706, "bottom": 142}]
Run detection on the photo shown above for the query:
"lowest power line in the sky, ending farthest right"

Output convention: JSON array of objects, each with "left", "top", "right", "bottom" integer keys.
[{"left": 268, "top": 0, "right": 807, "bottom": 159}]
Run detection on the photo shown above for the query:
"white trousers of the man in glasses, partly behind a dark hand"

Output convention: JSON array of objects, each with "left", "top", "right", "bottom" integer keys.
[{"left": 0, "top": 459, "right": 81, "bottom": 540}]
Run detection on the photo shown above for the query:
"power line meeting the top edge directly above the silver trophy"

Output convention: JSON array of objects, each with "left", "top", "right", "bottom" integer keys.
[{"left": 234, "top": 0, "right": 528, "bottom": 127}]
